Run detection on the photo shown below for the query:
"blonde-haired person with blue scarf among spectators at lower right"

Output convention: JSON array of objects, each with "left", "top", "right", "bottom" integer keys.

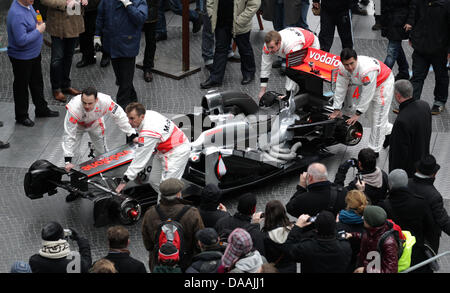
[{"left": 336, "top": 189, "right": 369, "bottom": 273}]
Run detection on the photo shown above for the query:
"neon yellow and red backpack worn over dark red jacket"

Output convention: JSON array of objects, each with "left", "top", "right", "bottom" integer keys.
[{"left": 377, "top": 219, "right": 416, "bottom": 272}]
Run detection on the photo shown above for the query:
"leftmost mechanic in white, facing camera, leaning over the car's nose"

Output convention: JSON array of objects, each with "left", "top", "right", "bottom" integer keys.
[{"left": 62, "top": 87, "right": 137, "bottom": 172}]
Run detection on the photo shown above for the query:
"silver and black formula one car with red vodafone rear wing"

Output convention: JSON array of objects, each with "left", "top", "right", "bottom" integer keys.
[{"left": 24, "top": 48, "right": 363, "bottom": 226}]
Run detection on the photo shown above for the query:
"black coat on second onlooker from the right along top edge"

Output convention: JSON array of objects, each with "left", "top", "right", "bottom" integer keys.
[{"left": 381, "top": 0, "right": 415, "bottom": 41}]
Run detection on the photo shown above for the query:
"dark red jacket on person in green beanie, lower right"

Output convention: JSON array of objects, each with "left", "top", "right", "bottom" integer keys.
[{"left": 352, "top": 224, "right": 398, "bottom": 273}]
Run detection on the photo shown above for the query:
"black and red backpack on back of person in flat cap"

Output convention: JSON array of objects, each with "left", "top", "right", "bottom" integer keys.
[{"left": 154, "top": 205, "right": 191, "bottom": 262}]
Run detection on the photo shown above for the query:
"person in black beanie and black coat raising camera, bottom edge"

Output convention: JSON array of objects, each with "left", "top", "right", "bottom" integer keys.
[{"left": 281, "top": 211, "right": 352, "bottom": 273}]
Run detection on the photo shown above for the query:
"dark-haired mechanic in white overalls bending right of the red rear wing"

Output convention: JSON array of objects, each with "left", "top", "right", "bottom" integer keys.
[{"left": 329, "top": 48, "right": 394, "bottom": 157}]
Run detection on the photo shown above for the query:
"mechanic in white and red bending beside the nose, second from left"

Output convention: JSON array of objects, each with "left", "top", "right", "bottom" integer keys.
[{"left": 116, "top": 102, "right": 191, "bottom": 197}]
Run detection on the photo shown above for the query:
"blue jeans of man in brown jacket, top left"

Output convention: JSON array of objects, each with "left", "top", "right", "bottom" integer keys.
[{"left": 50, "top": 37, "right": 78, "bottom": 90}]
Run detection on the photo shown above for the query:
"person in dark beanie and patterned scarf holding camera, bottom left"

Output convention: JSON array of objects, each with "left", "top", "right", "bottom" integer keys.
[{"left": 28, "top": 222, "right": 92, "bottom": 273}]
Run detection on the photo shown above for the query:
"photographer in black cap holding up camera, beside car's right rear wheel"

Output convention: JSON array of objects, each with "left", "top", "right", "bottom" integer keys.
[{"left": 334, "top": 148, "right": 389, "bottom": 205}]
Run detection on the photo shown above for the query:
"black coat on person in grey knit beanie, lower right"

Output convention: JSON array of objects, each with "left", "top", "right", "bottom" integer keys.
[{"left": 380, "top": 187, "right": 434, "bottom": 265}]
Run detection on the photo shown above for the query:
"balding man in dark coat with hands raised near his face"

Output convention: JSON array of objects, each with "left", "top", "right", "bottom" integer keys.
[{"left": 286, "top": 163, "right": 347, "bottom": 218}]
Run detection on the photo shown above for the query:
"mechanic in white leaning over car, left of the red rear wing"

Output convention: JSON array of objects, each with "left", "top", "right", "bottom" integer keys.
[{"left": 258, "top": 27, "right": 320, "bottom": 99}]
